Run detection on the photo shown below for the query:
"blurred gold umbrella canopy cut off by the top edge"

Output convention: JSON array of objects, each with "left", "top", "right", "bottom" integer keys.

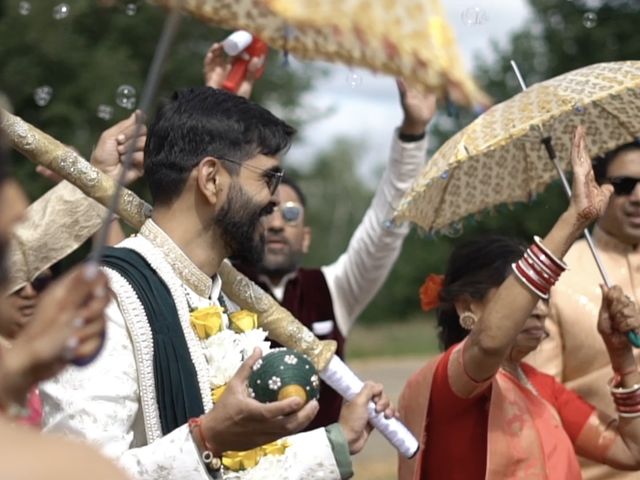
[{"left": 153, "top": 0, "right": 490, "bottom": 106}]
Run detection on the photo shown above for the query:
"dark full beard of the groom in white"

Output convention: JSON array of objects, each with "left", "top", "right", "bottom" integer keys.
[{"left": 215, "top": 182, "right": 275, "bottom": 265}]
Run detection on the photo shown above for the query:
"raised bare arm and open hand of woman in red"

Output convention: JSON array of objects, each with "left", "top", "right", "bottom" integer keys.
[{"left": 463, "top": 127, "right": 612, "bottom": 381}]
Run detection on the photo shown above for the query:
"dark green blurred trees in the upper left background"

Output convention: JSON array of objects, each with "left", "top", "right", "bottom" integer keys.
[{"left": 0, "top": 0, "right": 317, "bottom": 197}]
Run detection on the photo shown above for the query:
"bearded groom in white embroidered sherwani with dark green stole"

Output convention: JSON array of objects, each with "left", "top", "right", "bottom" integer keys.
[{"left": 41, "top": 87, "right": 393, "bottom": 480}]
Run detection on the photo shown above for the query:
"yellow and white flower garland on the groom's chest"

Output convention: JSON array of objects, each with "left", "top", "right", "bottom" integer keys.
[{"left": 190, "top": 305, "right": 289, "bottom": 472}]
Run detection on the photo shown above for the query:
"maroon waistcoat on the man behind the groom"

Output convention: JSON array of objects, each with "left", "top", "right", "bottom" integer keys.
[{"left": 236, "top": 265, "right": 345, "bottom": 430}]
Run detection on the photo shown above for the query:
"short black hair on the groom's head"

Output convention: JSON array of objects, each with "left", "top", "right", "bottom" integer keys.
[{"left": 144, "top": 87, "right": 295, "bottom": 205}]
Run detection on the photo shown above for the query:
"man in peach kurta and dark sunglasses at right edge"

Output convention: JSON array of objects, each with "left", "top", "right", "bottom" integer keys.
[{"left": 528, "top": 142, "right": 640, "bottom": 480}]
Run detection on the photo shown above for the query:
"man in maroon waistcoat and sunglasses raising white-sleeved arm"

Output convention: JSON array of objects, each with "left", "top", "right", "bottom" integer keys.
[{"left": 240, "top": 81, "right": 435, "bottom": 429}]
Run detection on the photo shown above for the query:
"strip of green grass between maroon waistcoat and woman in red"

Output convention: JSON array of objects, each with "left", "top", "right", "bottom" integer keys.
[{"left": 346, "top": 317, "right": 439, "bottom": 360}]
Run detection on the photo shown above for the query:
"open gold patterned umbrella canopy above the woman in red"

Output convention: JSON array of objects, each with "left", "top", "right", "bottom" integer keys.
[{"left": 395, "top": 61, "right": 640, "bottom": 231}]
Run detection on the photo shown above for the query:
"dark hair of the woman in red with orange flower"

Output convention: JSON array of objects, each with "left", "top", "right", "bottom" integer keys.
[{"left": 437, "top": 235, "right": 526, "bottom": 350}]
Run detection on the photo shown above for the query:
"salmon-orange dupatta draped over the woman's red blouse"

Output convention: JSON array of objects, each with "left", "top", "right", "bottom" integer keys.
[{"left": 398, "top": 344, "right": 582, "bottom": 480}]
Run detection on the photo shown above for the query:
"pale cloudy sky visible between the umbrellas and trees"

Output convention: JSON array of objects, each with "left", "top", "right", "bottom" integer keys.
[{"left": 285, "top": 0, "right": 530, "bottom": 184}]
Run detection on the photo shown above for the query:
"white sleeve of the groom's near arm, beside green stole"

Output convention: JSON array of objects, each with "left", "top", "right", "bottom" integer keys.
[{"left": 40, "top": 300, "right": 210, "bottom": 480}]
